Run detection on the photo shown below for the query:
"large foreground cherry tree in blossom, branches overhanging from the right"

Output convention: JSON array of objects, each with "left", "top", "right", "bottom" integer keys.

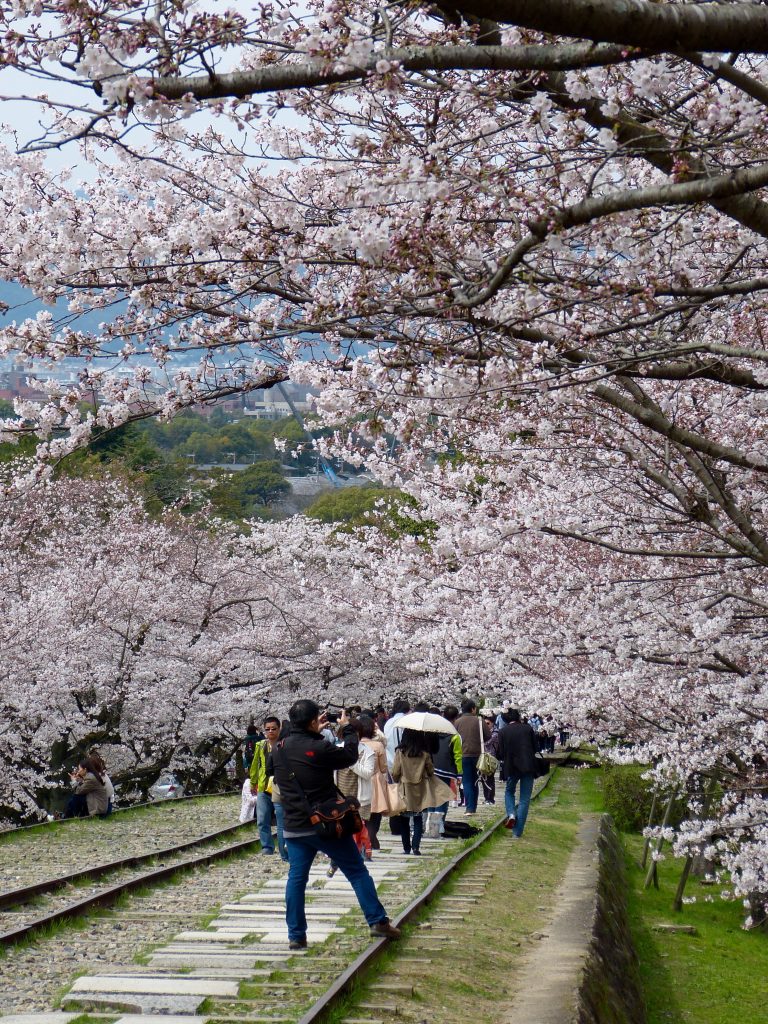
[{"left": 0, "top": 0, "right": 768, "bottom": 921}]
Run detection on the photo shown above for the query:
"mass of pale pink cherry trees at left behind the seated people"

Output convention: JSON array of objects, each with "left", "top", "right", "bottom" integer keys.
[{"left": 0, "top": 468, "right": 421, "bottom": 816}]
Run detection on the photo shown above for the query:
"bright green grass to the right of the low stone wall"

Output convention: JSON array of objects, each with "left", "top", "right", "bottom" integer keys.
[{"left": 584, "top": 771, "right": 768, "bottom": 1024}]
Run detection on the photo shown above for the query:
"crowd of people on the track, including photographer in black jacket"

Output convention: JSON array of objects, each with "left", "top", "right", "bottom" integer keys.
[{"left": 241, "top": 698, "right": 568, "bottom": 949}]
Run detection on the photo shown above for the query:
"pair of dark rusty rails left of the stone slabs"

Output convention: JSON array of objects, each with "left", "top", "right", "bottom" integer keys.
[{"left": 0, "top": 822, "right": 259, "bottom": 946}]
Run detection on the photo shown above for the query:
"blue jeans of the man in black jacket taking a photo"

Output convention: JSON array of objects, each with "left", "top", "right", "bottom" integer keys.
[{"left": 286, "top": 836, "right": 387, "bottom": 942}]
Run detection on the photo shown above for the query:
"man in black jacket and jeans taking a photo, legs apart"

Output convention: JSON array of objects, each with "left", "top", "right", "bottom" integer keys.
[{"left": 267, "top": 700, "right": 400, "bottom": 949}]
